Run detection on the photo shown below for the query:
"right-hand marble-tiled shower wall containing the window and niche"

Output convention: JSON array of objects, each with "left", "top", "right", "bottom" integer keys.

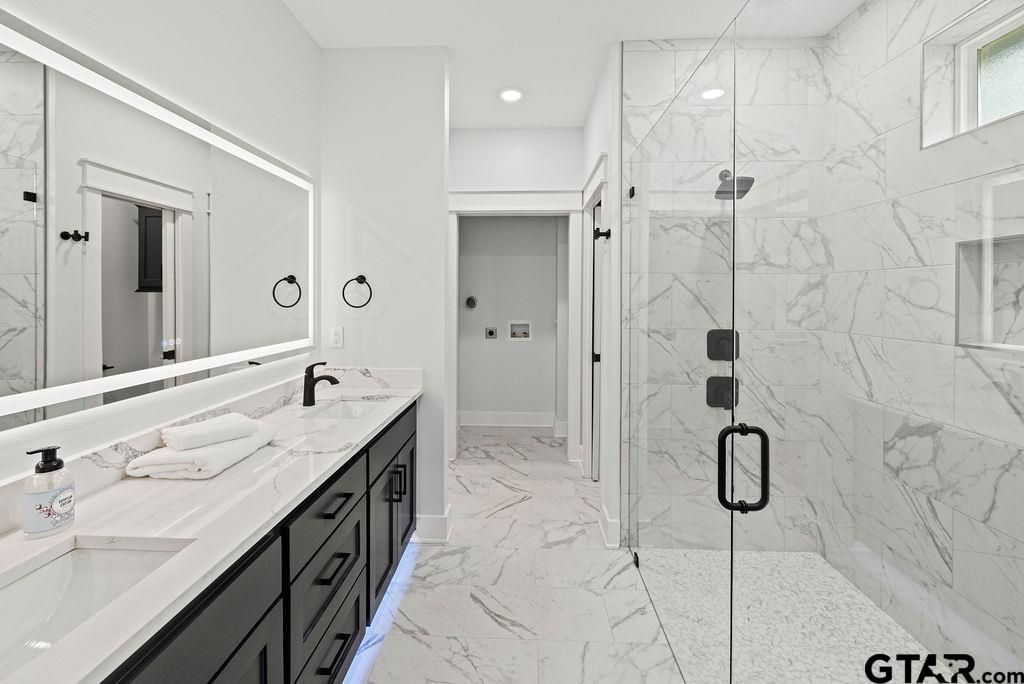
[{"left": 819, "top": 0, "right": 1024, "bottom": 667}]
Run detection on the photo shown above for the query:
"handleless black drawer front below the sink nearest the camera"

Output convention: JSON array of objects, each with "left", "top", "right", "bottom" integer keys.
[{"left": 117, "top": 537, "right": 284, "bottom": 684}]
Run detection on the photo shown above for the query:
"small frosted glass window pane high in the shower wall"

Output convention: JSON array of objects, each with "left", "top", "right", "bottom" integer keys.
[{"left": 978, "top": 26, "right": 1024, "bottom": 126}]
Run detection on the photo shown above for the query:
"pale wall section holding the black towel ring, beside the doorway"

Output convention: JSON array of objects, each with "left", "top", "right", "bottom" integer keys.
[{"left": 322, "top": 48, "right": 449, "bottom": 537}]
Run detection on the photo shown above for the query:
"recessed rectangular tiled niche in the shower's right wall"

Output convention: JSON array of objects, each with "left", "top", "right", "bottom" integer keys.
[{"left": 956, "top": 234, "right": 1024, "bottom": 350}]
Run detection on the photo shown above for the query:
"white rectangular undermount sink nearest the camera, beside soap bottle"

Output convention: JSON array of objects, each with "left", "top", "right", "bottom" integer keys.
[{"left": 0, "top": 536, "right": 193, "bottom": 681}]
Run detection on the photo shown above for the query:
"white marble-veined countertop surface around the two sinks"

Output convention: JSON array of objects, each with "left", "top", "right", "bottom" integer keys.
[{"left": 0, "top": 387, "right": 421, "bottom": 682}]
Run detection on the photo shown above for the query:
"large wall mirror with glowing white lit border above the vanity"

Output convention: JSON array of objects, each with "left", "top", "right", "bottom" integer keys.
[{"left": 0, "top": 13, "right": 315, "bottom": 429}]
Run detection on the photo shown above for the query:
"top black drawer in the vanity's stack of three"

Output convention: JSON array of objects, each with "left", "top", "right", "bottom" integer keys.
[{"left": 288, "top": 454, "right": 367, "bottom": 581}]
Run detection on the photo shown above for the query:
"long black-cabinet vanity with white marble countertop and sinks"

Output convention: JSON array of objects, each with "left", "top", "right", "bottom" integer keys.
[{"left": 0, "top": 387, "right": 420, "bottom": 682}]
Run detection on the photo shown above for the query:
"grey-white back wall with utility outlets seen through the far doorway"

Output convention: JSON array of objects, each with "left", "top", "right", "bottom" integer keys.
[{"left": 459, "top": 216, "right": 567, "bottom": 426}]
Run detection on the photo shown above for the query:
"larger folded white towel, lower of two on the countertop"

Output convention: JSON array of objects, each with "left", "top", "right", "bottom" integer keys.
[{"left": 128, "top": 421, "right": 278, "bottom": 480}]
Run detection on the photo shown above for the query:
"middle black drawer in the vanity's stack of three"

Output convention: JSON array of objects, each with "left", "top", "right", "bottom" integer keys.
[{"left": 289, "top": 498, "right": 367, "bottom": 680}]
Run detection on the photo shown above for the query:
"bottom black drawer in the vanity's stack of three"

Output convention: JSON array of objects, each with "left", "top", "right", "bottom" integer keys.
[{"left": 298, "top": 574, "right": 367, "bottom": 684}]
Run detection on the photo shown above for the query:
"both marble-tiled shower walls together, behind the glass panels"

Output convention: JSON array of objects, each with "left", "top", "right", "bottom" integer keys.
[{"left": 624, "top": 0, "right": 1024, "bottom": 668}]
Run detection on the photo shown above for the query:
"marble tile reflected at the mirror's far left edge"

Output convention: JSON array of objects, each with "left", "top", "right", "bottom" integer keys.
[{"left": 0, "top": 46, "right": 44, "bottom": 430}]
